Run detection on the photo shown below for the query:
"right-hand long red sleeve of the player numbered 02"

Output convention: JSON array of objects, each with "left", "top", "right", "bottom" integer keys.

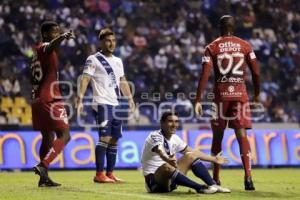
[{"left": 247, "top": 49, "right": 260, "bottom": 102}]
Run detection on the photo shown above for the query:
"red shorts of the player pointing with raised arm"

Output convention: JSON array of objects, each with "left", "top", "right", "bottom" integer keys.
[{"left": 31, "top": 101, "right": 69, "bottom": 131}]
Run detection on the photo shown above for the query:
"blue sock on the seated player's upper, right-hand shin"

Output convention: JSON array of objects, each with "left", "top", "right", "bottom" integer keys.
[{"left": 191, "top": 159, "right": 216, "bottom": 185}]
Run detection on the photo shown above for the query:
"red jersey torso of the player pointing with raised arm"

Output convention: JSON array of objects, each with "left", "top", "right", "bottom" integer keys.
[{"left": 31, "top": 43, "right": 61, "bottom": 102}]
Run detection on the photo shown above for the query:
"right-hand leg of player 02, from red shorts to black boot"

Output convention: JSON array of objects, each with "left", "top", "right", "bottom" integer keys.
[{"left": 229, "top": 102, "right": 255, "bottom": 190}]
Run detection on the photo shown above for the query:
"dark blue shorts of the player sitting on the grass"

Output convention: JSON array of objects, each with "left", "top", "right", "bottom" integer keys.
[{"left": 145, "top": 174, "right": 177, "bottom": 193}]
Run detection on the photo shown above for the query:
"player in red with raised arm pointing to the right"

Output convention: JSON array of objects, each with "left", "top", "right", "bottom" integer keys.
[{"left": 31, "top": 21, "right": 74, "bottom": 187}]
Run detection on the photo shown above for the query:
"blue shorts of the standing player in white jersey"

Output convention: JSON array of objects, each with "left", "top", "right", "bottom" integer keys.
[{"left": 94, "top": 104, "right": 122, "bottom": 140}]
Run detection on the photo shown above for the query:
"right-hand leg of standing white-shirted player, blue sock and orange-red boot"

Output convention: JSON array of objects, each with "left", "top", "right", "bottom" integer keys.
[{"left": 106, "top": 119, "right": 124, "bottom": 183}]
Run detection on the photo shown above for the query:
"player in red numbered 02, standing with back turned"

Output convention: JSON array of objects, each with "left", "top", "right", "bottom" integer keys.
[{"left": 195, "top": 15, "right": 260, "bottom": 190}]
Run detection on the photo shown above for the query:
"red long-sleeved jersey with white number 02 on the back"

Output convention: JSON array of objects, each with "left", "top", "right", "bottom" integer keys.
[{"left": 196, "top": 36, "right": 259, "bottom": 102}]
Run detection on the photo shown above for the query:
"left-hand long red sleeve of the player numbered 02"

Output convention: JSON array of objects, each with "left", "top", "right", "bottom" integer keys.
[{"left": 196, "top": 46, "right": 213, "bottom": 102}]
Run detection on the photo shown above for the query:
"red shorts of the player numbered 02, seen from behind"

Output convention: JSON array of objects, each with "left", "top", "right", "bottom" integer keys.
[{"left": 211, "top": 101, "right": 252, "bottom": 129}]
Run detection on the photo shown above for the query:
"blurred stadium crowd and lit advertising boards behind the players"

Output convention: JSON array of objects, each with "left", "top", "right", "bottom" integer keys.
[{"left": 0, "top": 0, "right": 300, "bottom": 184}]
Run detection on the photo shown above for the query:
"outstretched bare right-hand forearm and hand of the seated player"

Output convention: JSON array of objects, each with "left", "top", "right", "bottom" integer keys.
[{"left": 182, "top": 146, "right": 228, "bottom": 164}]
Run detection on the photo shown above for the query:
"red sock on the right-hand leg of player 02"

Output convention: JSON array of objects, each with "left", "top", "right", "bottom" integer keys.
[{"left": 238, "top": 136, "right": 251, "bottom": 177}]
